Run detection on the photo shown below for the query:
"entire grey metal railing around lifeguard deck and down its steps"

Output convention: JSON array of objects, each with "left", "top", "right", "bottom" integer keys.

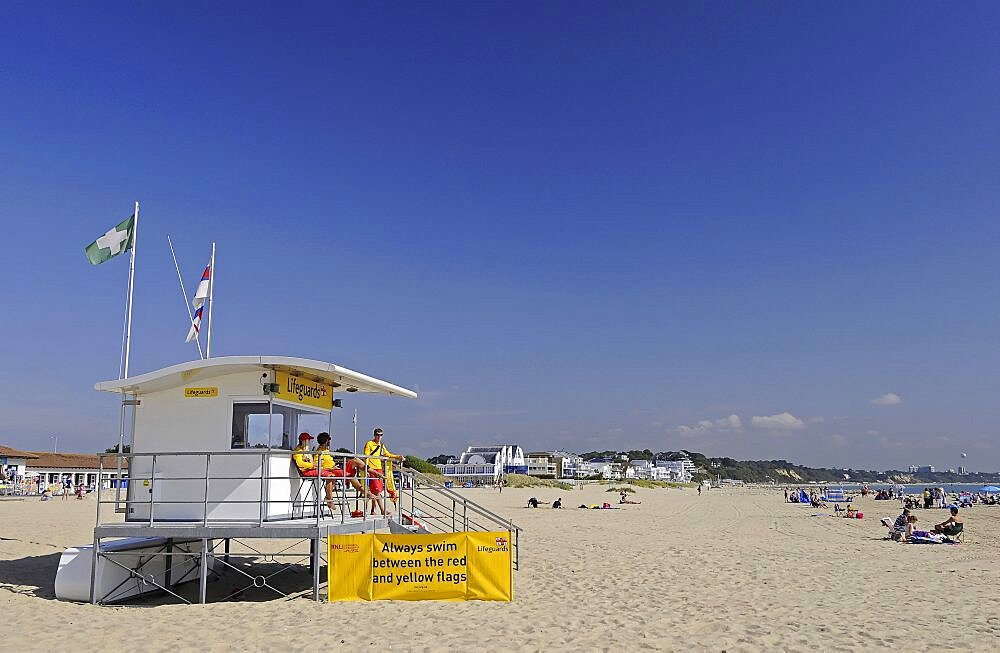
[{"left": 97, "top": 449, "right": 521, "bottom": 569}]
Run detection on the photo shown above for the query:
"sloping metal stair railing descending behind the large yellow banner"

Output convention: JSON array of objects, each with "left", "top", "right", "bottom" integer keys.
[{"left": 399, "top": 468, "right": 521, "bottom": 569}]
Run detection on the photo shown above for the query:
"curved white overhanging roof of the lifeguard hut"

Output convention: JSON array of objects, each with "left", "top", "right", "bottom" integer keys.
[{"left": 94, "top": 356, "right": 417, "bottom": 399}]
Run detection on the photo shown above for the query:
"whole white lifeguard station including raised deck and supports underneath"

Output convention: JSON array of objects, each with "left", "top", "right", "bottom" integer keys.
[{"left": 56, "top": 356, "right": 417, "bottom": 603}]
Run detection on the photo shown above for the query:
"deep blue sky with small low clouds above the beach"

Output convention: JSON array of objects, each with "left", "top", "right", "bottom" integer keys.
[{"left": 0, "top": 2, "right": 1000, "bottom": 470}]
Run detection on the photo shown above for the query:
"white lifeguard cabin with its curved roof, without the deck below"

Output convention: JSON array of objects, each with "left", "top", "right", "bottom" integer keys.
[{"left": 95, "top": 356, "right": 417, "bottom": 523}]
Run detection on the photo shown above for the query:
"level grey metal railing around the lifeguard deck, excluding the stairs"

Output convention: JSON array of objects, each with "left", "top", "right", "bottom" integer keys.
[{"left": 97, "top": 449, "right": 402, "bottom": 526}]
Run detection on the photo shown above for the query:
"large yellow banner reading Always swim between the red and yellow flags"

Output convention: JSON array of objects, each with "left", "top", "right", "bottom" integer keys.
[{"left": 327, "top": 531, "right": 514, "bottom": 602}]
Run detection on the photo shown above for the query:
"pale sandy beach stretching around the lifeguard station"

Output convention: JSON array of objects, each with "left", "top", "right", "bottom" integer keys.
[{"left": 0, "top": 485, "right": 1000, "bottom": 652}]
